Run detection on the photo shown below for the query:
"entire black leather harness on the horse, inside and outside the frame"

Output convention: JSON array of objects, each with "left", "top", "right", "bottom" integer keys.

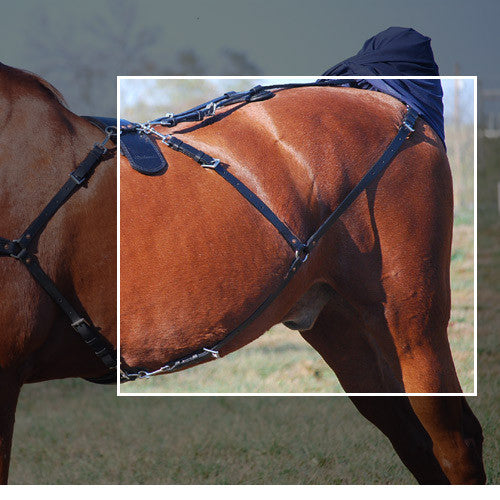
[{"left": 0, "top": 80, "right": 419, "bottom": 384}]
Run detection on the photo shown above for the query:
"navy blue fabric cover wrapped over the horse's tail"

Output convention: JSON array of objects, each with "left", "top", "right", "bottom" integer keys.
[{"left": 323, "top": 27, "right": 444, "bottom": 142}]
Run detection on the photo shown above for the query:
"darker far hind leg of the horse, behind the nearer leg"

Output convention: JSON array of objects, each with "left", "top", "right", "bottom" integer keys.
[{"left": 301, "top": 298, "right": 448, "bottom": 484}]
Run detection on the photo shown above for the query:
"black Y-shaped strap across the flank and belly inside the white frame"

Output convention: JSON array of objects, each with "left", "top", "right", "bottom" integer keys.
[{"left": 122, "top": 104, "right": 419, "bottom": 381}]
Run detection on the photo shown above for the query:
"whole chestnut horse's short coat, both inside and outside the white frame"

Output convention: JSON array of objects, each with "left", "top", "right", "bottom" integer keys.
[{"left": 0, "top": 65, "right": 484, "bottom": 483}]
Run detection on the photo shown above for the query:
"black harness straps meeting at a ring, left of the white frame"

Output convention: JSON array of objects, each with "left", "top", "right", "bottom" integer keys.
[{"left": 0, "top": 129, "right": 117, "bottom": 376}]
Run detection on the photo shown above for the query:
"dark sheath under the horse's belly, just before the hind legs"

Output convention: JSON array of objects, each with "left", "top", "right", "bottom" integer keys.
[{"left": 282, "top": 283, "right": 335, "bottom": 331}]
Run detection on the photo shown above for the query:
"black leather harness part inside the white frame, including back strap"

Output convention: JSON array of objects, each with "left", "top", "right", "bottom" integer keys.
[{"left": 120, "top": 80, "right": 419, "bottom": 381}]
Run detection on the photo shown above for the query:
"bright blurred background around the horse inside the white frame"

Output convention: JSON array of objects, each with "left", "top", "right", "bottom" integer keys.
[{"left": 119, "top": 77, "right": 474, "bottom": 393}]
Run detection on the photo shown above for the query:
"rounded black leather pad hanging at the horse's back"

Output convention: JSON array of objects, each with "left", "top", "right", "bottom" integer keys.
[{"left": 120, "top": 120, "right": 168, "bottom": 175}]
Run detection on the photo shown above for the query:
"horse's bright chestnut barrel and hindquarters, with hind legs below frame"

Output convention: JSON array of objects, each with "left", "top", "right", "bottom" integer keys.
[{"left": 120, "top": 87, "right": 485, "bottom": 483}]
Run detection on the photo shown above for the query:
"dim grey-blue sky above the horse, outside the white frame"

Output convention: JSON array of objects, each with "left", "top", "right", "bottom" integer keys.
[{"left": 0, "top": 0, "right": 500, "bottom": 114}]
